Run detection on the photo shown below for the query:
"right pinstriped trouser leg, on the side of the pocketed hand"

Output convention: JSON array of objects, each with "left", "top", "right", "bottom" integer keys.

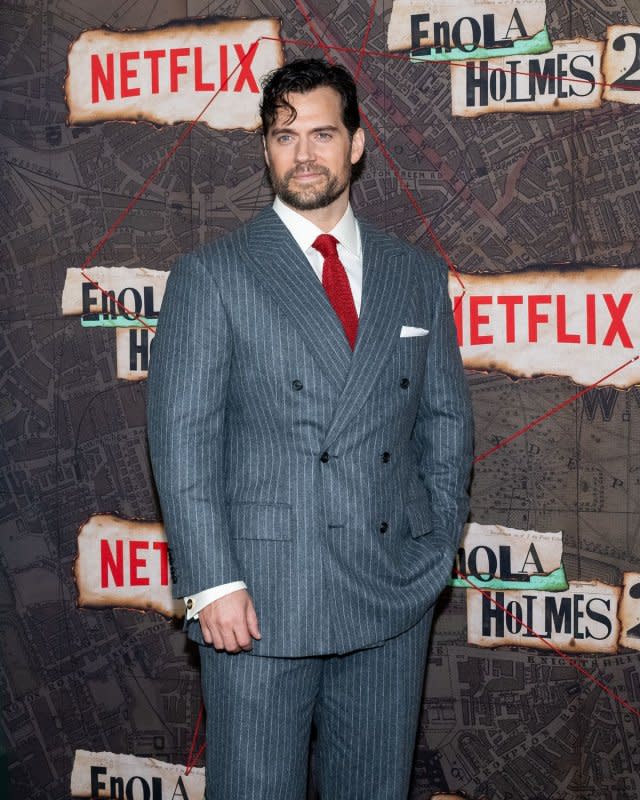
[{"left": 315, "top": 609, "right": 433, "bottom": 800}]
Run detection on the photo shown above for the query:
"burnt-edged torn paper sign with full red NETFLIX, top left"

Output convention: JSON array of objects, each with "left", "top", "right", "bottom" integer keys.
[{"left": 65, "top": 17, "right": 284, "bottom": 130}]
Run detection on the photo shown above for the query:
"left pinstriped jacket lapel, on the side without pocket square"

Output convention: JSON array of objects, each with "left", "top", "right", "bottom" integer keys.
[{"left": 247, "top": 207, "right": 352, "bottom": 389}]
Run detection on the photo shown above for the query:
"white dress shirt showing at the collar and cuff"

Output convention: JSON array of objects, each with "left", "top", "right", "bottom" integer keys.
[{"left": 184, "top": 197, "right": 362, "bottom": 619}]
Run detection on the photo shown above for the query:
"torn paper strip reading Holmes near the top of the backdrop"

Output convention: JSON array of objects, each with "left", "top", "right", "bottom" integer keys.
[{"left": 450, "top": 39, "right": 604, "bottom": 117}]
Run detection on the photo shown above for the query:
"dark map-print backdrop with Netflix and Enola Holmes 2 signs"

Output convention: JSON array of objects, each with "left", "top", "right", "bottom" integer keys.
[{"left": 0, "top": 0, "right": 640, "bottom": 800}]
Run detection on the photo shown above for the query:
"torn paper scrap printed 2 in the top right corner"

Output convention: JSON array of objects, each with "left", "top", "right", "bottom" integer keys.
[{"left": 602, "top": 25, "right": 640, "bottom": 105}]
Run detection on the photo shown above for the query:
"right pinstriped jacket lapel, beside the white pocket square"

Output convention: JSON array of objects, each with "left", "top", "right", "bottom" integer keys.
[{"left": 325, "top": 222, "right": 410, "bottom": 445}]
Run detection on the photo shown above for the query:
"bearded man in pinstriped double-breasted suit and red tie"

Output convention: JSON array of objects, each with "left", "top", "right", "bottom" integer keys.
[{"left": 149, "top": 59, "right": 471, "bottom": 800}]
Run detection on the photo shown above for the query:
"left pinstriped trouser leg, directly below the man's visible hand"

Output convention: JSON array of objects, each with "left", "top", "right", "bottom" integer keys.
[{"left": 200, "top": 646, "right": 322, "bottom": 800}]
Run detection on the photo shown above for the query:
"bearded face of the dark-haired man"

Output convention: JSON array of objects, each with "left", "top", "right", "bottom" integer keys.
[{"left": 264, "top": 86, "right": 364, "bottom": 211}]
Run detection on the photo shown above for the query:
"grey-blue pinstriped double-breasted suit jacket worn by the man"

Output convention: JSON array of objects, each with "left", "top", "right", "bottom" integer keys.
[{"left": 148, "top": 208, "right": 471, "bottom": 656}]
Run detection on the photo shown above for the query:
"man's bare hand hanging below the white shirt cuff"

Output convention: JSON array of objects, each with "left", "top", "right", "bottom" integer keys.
[{"left": 198, "top": 589, "right": 261, "bottom": 653}]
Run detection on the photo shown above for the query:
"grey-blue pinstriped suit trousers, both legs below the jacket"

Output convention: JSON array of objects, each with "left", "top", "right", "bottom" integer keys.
[{"left": 200, "top": 612, "right": 432, "bottom": 800}]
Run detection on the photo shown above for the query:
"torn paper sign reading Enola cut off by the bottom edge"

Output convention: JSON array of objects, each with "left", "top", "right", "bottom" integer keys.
[{"left": 70, "top": 750, "right": 205, "bottom": 800}]
